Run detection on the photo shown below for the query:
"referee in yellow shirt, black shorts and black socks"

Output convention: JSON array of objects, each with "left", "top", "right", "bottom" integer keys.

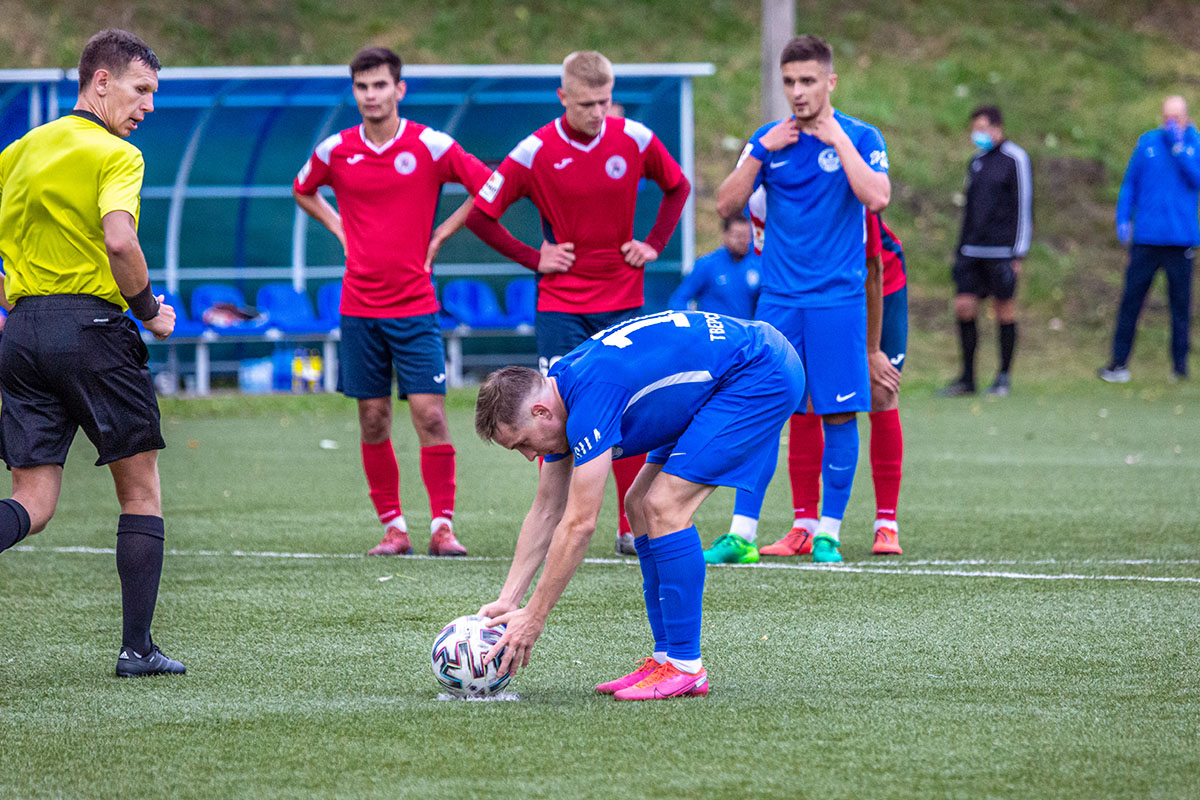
[{"left": 0, "top": 30, "right": 185, "bottom": 678}]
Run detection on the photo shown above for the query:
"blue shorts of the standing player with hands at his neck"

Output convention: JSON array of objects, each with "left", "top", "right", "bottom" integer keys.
[{"left": 755, "top": 297, "right": 871, "bottom": 414}]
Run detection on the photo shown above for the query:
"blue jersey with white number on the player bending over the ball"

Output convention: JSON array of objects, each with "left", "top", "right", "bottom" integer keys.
[{"left": 546, "top": 311, "right": 786, "bottom": 465}]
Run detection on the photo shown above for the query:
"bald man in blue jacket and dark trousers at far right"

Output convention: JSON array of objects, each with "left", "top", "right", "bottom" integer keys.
[{"left": 1099, "top": 96, "right": 1200, "bottom": 384}]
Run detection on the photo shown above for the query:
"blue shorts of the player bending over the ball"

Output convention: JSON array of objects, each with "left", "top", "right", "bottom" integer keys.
[{"left": 646, "top": 330, "right": 805, "bottom": 489}]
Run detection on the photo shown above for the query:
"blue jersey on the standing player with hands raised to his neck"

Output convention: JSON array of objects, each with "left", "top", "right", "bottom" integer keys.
[{"left": 743, "top": 110, "right": 888, "bottom": 308}]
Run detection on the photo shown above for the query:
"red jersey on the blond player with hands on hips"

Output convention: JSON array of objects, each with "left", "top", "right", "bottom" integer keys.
[{"left": 475, "top": 116, "right": 683, "bottom": 314}]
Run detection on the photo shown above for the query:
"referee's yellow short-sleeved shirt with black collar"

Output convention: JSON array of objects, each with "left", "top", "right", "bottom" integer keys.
[{"left": 0, "top": 115, "right": 145, "bottom": 308}]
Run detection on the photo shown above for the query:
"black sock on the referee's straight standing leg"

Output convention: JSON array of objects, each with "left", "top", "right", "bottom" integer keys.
[{"left": 116, "top": 513, "right": 164, "bottom": 656}]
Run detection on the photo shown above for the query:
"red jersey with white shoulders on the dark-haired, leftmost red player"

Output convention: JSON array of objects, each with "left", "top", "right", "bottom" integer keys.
[{"left": 294, "top": 119, "right": 488, "bottom": 318}]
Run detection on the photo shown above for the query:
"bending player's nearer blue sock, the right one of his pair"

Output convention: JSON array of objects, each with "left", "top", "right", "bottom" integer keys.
[{"left": 650, "top": 525, "right": 704, "bottom": 660}]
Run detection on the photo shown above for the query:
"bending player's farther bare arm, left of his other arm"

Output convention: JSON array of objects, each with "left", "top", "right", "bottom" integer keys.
[{"left": 479, "top": 456, "right": 574, "bottom": 618}]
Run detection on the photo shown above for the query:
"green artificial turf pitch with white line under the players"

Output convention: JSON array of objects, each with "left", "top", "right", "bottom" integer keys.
[{"left": 0, "top": 381, "right": 1200, "bottom": 798}]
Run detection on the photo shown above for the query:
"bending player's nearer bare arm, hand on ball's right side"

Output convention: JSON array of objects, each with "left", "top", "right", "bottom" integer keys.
[{"left": 484, "top": 451, "right": 612, "bottom": 675}]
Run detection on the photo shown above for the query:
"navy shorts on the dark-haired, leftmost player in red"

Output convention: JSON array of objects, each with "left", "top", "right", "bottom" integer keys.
[{"left": 337, "top": 314, "right": 446, "bottom": 399}]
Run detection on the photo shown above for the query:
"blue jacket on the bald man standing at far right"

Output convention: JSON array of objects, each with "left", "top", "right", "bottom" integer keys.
[{"left": 1117, "top": 125, "right": 1200, "bottom": 247}]
